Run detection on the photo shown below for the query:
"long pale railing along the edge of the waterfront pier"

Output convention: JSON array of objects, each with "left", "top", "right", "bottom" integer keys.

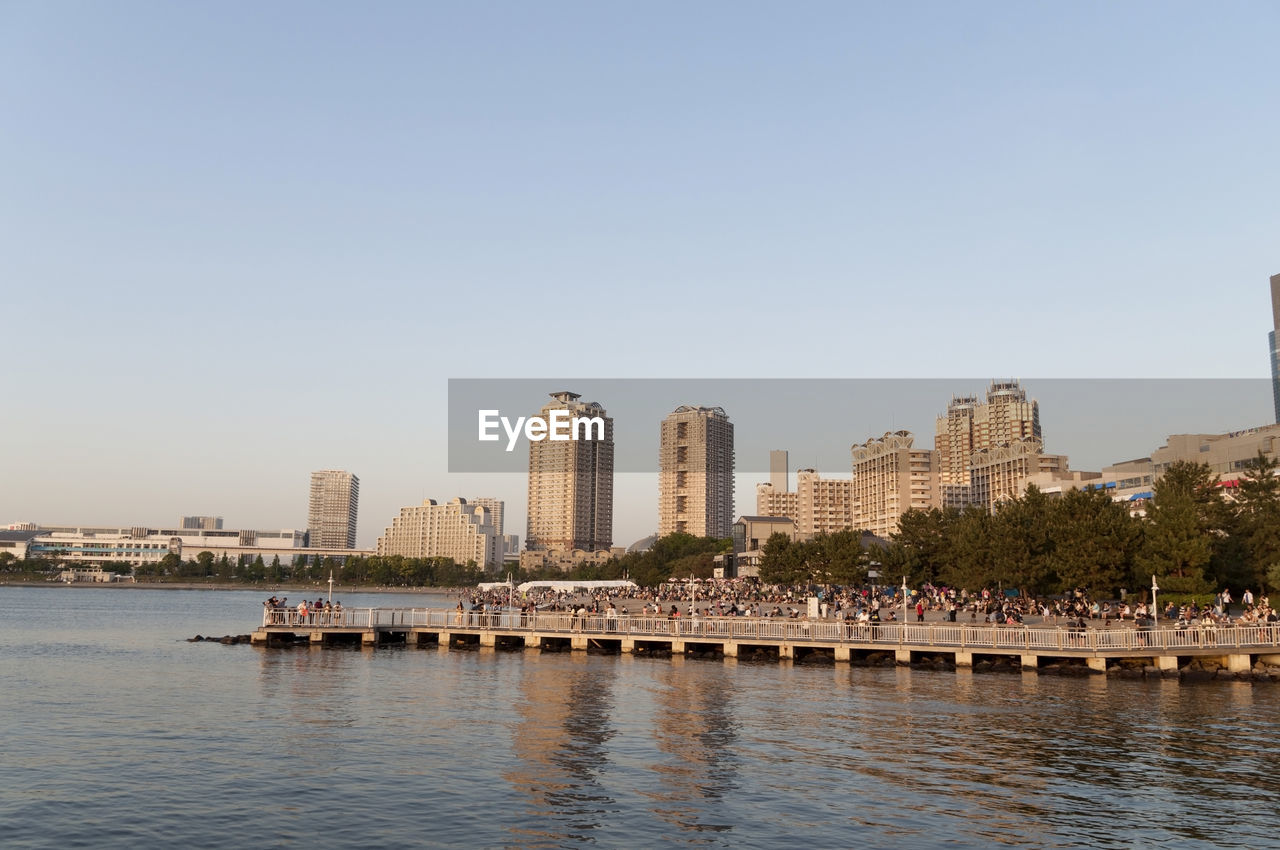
[{"left": 262, "top": 608, "right": 1280, "bottom": 653}]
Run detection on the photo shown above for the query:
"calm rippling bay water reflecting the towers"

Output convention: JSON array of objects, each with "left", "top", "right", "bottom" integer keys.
[{"left": 0, "top": 588, "right": 1280, "bottom": 847}]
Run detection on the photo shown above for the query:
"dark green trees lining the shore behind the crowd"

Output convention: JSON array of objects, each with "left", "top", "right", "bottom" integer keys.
[{"left": 0, "top": 453, "right": 1280, "bottom": 600}]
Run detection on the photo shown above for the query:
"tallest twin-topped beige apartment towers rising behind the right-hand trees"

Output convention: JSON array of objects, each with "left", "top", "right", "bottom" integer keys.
[{"left": 933, "top": 380, "right": 1042, "bottom": 507}]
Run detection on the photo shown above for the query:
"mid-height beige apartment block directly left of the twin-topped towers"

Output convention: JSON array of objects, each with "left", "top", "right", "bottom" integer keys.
[{"left": 852, "top": 431, "right": 940, "bottom": 538}]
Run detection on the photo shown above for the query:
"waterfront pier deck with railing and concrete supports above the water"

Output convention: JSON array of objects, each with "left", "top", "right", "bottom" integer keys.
[{"left": 252, "top": 608, "right": 1280, "bottom": 673}]
